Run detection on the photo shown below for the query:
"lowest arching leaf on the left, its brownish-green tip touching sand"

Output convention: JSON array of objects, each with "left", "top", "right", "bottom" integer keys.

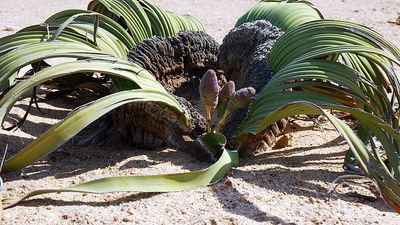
[{"left": 3, "top": 89, "right": 185, "bottom": 172}]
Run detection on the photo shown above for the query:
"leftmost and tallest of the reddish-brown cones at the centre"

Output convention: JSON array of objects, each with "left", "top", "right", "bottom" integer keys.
[{"left": 200, "top": 70, "right": 220, "bottom": 120}]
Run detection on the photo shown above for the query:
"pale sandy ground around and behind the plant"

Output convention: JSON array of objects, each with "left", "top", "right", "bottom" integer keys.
[{"left": 0, "top": 0, "right": 400, "bottom": 224}]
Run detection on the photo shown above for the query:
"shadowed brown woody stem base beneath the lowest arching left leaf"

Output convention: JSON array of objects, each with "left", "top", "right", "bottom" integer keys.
[{"left": 112, "top": 96, "right": 207, "bottom": 151}]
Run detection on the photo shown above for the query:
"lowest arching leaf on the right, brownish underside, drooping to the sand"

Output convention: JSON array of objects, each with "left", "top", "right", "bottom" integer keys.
[{"left": 241, "top": 101, "right": 400, "bottom": 210}]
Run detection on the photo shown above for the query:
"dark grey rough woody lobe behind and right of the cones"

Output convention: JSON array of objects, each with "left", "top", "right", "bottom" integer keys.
[{"left": 218, "top": 20, "right": 283, "bottom": 92}]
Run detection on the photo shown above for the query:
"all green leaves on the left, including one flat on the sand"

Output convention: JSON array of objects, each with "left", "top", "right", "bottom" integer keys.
[{"left": 0, "top": 0, "right": 237, "bottom": 208}]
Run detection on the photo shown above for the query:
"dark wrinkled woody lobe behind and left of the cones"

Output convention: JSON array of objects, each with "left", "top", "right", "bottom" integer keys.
[{"left": 128, "top": 31, "right": 224, "bottom": 100}]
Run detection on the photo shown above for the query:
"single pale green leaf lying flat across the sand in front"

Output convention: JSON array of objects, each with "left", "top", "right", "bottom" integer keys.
[{"left": 4, "top": 149, "right": 239, "bottom": 209}]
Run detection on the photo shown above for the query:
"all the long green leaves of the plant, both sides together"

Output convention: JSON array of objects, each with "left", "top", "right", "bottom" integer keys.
[{"left": 0, "top": 0, "right": 400, "bottom": 212}]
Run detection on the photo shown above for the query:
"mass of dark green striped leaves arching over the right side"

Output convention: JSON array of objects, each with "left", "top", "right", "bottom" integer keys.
[{"left": 237, "top": 1, "right": 400, "bottom": 211}]
